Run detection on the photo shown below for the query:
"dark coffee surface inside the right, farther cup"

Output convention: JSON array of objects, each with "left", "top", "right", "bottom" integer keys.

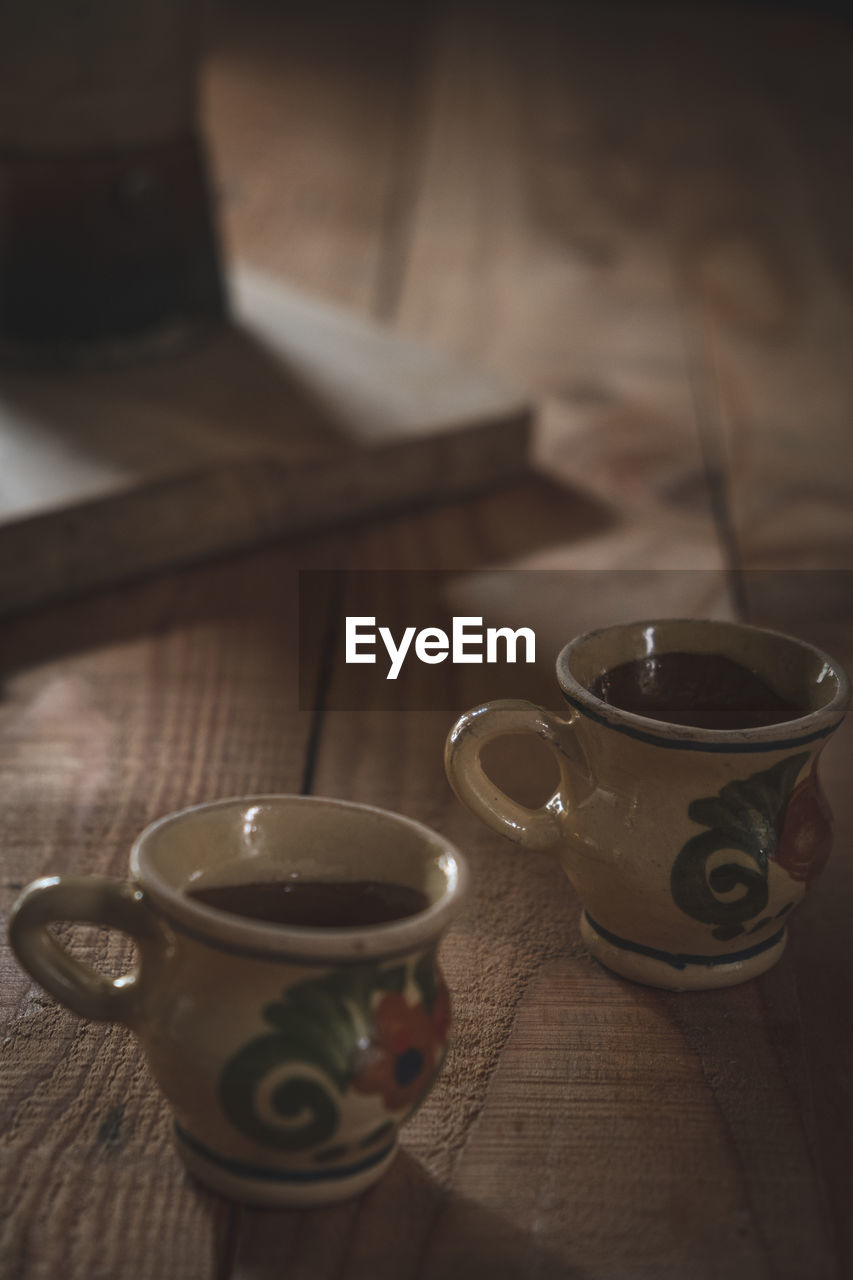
[{"left": 590, "top": 653, "right": 807, "bottom": 728}]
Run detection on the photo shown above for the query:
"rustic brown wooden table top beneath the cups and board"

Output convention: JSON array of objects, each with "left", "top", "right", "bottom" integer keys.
[{"left": 0, "top": 3, "right": 853, "bottom": 1280}]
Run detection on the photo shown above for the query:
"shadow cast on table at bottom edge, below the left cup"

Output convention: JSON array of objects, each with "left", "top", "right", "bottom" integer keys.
[{"left": 224, "top": 1151, "right": 583, "bottom": 1280}]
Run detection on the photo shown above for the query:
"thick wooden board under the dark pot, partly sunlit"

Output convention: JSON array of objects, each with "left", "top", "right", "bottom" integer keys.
[{"left": 0, "top": 269, "right": 530, "bottom": 613}]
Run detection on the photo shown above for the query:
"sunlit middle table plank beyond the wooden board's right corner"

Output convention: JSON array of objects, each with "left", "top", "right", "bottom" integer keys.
[{"left": 397, "top": 5, "right": 712, "bottom": 527}]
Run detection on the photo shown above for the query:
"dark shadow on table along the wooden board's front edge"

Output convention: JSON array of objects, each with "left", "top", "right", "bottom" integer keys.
[{"left": 0, "top": 474, "right": 616, "bottom": 678}]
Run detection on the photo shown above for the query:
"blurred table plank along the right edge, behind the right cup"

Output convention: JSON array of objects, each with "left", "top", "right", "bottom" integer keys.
[{"left": 645, "top": 13, "right": 853, "bottom": 568}]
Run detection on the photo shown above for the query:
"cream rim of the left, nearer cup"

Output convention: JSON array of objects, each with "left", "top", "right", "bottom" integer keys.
[{"left": 131, "top": 792, "right": 469, "bottom": 966}]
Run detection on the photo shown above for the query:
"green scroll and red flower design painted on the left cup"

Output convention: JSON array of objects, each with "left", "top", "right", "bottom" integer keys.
[{"left": 219, "top": 948, "right": 451, "bottom": 1160}]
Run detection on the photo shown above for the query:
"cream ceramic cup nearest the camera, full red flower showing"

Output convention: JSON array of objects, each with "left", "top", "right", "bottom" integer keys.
[{"left": 9, "top": 796, "right": 467, "bottom": 1206}]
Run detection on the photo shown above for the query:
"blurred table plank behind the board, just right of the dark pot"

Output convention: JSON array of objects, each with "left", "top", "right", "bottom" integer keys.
[{"left": 202, "top": 0, "right": 430, "bottom": 320}]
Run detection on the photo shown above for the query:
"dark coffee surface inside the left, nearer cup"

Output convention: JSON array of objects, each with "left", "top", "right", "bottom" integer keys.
[{"left": 187, "top": 879, "right": 429, "bottom": 929}]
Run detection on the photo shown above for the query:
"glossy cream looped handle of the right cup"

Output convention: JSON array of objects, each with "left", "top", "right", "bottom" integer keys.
[{"left": 444, "top": 699, "right": 589, "bottom": 849}]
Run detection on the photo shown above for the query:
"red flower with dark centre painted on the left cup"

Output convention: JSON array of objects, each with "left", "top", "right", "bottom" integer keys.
[{"left": 352, "top": 982, "right": 450, "bottom": 1111}]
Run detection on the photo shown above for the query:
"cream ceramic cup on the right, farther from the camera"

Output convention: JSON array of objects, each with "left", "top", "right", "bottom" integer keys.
[{"left": 446, "top": 620, "right": 849, "bottom": 989}]
